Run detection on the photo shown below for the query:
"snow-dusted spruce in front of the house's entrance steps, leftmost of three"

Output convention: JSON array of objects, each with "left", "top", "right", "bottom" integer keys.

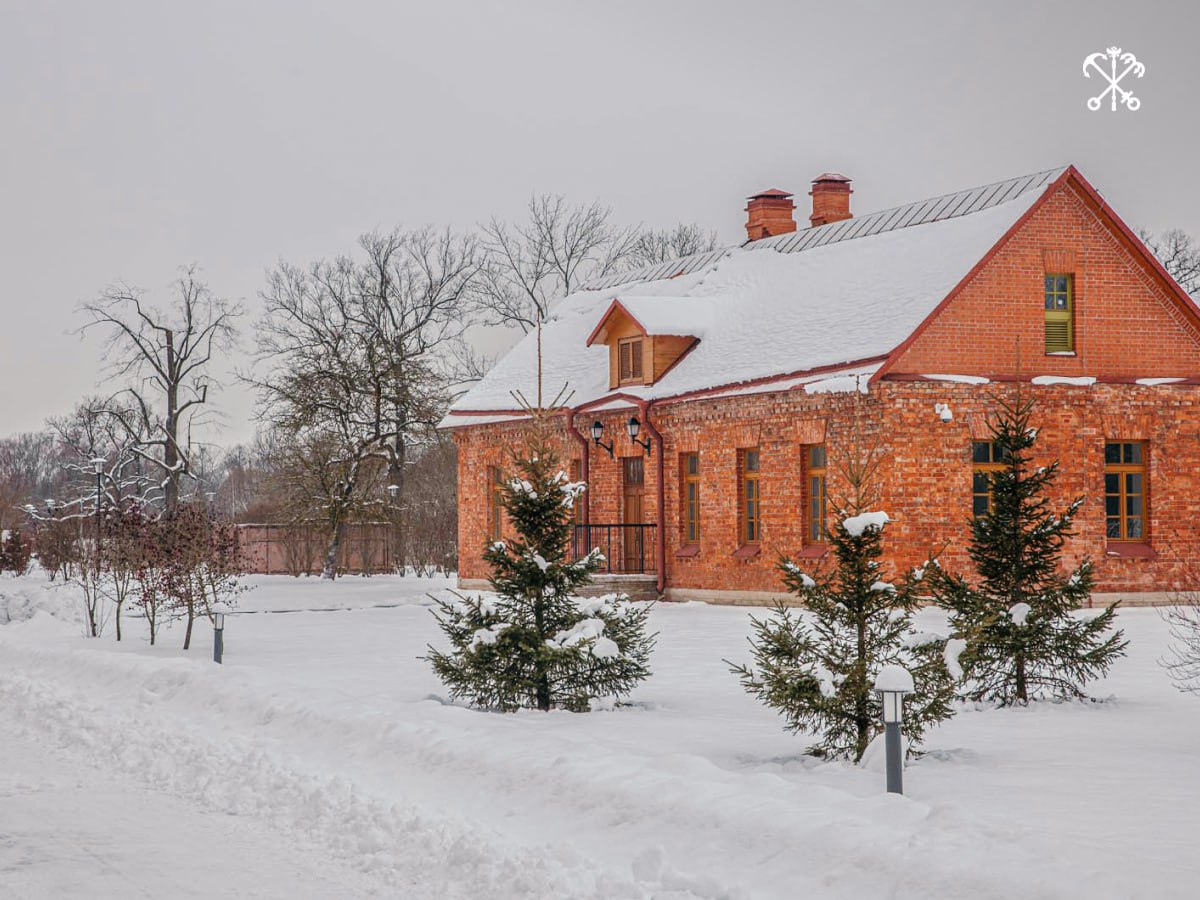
[{"left": 427, "top": 428, "right": 654, "bottom": 712}]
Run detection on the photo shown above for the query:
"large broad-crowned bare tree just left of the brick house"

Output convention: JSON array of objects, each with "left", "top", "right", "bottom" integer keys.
[{"left": 247, "top": 229, "right": 479, "bottom": 578}]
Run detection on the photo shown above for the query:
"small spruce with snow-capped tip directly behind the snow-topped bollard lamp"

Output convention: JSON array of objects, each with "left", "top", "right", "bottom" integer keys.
[{"left": 732, "top": 436, "right": 956, "bottom": 762}]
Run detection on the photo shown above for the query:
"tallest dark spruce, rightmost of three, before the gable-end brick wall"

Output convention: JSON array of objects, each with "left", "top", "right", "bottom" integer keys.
[{"left": 930, "top": 392, "right": 1128, "bottom": 706}]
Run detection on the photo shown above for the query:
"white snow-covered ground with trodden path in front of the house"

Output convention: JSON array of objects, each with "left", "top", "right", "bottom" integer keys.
[{"left": 0, "top": 577, "right": 1200, "bottom": 900}]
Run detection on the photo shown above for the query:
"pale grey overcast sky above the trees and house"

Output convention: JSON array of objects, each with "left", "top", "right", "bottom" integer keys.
[{"left": 0, "top": 0, "right": 1200, "bottom": 443}]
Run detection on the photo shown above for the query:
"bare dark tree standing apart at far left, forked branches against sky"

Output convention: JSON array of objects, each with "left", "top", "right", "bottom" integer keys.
[{"left": 80, "top": 266, "right": 241, "bottom": 517}]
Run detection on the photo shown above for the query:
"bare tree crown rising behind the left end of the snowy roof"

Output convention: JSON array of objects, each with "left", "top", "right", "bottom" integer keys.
[{"left": 479, "top": 194, "right": 637, "bottom": 332}]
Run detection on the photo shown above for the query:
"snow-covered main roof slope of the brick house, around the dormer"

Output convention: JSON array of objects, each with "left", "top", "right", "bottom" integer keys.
[{"left": 444, "top": 169, "right": 1063, "bottom": 425}]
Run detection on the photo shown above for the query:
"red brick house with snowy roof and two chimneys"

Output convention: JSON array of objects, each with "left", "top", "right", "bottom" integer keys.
[{"left": 444, "top": 167, "right": 1200, "bottom": 602}]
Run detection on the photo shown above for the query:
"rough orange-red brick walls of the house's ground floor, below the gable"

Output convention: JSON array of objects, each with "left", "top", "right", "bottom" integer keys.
[{"left": 456, "top": 382, "right": 1200, "bottom": 593}]
